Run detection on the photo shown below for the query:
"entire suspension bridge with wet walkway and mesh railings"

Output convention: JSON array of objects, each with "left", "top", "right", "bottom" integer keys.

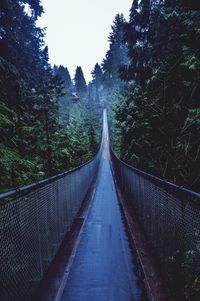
[{"left": 0, "top": 109, "right": 200, "bottom": 301}]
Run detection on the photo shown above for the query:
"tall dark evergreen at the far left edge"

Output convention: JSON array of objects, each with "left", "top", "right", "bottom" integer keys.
[{"left": 0, "top": 0, "right": 56, "bottom": 186}]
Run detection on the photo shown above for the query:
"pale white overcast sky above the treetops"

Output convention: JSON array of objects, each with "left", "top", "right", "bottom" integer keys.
[{"left": 38, "top": 0, "right": 132, "bottom": 82}]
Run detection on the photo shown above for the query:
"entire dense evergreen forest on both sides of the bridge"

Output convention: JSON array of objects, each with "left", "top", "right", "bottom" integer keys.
[{"left": 0, "top": 0, "right": 200, "bottom": 191}]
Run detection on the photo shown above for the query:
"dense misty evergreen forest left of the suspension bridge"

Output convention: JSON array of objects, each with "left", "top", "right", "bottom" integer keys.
[{"left": 0, "top": 0, "right": 101, "bottom": 191}]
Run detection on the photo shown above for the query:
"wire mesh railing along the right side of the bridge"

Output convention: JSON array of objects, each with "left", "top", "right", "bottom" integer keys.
[{"left": 111, "top": 150, "right": 200, "bottom": 301}]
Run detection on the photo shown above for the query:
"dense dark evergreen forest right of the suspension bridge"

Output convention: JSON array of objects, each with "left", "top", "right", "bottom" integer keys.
[{"left": 102, "top": 0, "right": 200, "bottom": 191}]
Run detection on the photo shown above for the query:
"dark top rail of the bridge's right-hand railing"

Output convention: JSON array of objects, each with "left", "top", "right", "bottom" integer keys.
[{"left": 110, "top": 148, "right": 200, "bottom": 200}]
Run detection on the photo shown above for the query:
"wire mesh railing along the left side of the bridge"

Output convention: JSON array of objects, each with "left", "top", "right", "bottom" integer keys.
[{"left": 0, "top": 150, "right": 101, "bottom": 301}]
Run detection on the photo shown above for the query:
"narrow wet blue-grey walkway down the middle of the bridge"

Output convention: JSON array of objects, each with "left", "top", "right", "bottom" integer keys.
[{"left": 61, "top": 111, "right": 141, "bottom": 301}]
